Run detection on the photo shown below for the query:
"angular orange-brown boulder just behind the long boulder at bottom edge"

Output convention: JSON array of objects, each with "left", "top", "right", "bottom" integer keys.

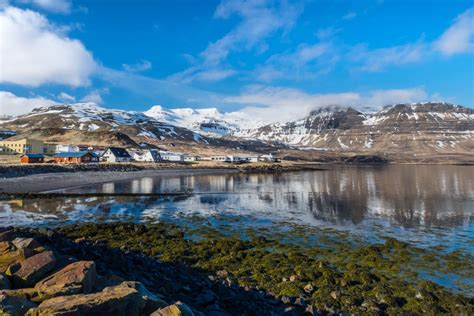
[{"left": 35, "top": 261, "right": 97, "bottom": 300}]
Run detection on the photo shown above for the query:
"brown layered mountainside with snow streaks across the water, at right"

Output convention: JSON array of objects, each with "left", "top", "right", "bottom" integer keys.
[{"left": 235, "top": 103, "right": 474, "bottom": 159}]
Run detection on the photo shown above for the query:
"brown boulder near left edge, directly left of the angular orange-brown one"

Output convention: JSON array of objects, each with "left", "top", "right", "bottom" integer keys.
[{"left": 6, "top": 251, "right": 56, "bottom": 288}]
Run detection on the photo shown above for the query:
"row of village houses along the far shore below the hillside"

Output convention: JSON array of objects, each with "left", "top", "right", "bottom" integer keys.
[{"left": 0, "top": 137, "right": 279, "bottom": 164}]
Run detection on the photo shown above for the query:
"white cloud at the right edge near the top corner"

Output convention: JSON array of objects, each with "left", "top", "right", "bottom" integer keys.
[{"left": 433, "top": 8, "right": 474, "bottom": 56}]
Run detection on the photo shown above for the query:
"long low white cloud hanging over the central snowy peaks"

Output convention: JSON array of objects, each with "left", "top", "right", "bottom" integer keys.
[{"left": 223, "top": 86, "right": 429, "bottom": 122}]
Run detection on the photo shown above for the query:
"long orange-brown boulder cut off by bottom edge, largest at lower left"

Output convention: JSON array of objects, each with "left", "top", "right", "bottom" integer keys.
[{"left": 27, "top": 282, "right": 143, "bottom": 316}]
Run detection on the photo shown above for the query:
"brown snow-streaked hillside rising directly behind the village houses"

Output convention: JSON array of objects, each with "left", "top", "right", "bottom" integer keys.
[{"left": 0, "top": 103, "right": 282, "bottom": 153}]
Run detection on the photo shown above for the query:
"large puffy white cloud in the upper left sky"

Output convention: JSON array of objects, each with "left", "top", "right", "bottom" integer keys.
[{"left": 0, "top": 6, "right": 96, "bottom": 86}]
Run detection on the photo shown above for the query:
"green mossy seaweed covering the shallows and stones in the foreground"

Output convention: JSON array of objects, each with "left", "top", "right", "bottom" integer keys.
[{"left": 58, "top": 223, "right": 474, "bottom": 315}]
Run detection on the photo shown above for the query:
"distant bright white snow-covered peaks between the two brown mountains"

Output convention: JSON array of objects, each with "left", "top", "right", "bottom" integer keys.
[{"left": 144, "top": 105, "right": 265, "bottom": 137}]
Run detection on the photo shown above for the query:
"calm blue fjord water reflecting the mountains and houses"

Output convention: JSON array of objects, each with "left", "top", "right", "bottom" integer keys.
[{"left": 0, "top": 165, "right": 474, "bottom": 253}]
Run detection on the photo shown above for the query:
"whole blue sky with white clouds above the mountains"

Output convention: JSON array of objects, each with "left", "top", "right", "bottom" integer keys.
[{"left": 0, "top": 0, "right": 474, "bottom": 121}]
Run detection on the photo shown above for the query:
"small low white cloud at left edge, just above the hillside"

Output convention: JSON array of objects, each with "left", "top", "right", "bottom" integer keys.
[{"left": 0, "top": 91, "right": 55, "bottom": 116}]
